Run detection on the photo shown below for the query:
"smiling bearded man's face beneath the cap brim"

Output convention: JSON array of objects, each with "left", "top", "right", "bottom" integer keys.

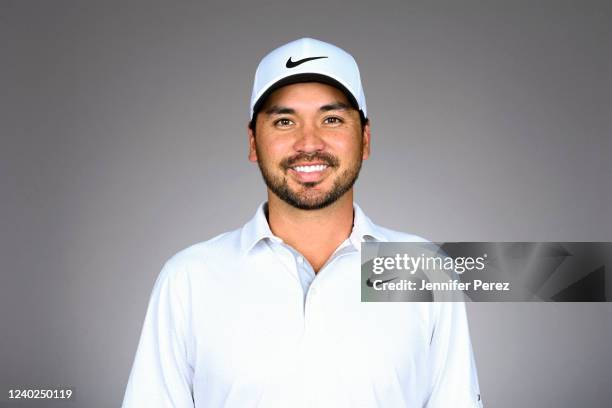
[{"left": 249, "top": 82, "right": 370, "bottom": 210}]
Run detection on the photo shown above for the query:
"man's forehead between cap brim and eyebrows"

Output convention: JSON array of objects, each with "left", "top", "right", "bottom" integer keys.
[{"left": 262, "top": 82, "right": 349, "bottom": 110}]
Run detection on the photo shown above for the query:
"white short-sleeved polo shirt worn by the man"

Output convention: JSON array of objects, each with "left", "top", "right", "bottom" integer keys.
[{"left": 123, "top": 203, "right": 482, "bottom": 408}]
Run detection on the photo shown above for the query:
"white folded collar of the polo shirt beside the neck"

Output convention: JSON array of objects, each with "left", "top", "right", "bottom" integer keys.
[{"left": 240, "top": 202, "right": 388, "bottom": 255}]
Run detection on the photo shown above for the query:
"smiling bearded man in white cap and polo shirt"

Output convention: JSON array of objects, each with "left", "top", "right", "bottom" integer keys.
[{"left": 123, "top": 38, "right": 481, "bottom": 408}]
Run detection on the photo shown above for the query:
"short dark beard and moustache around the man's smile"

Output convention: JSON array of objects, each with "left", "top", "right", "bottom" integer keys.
[{"left": 256, "top": 146, "right": 363, "bottom": 210}]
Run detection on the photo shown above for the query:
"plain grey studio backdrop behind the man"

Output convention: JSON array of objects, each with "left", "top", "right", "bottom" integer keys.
[{"left": 0, "top": 0, "right": 612, "bottom": 408}]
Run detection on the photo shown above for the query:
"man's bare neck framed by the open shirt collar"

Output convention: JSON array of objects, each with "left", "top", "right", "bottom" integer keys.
[{"left": 268, "top": 189, "right": 353, "bottom": 272}]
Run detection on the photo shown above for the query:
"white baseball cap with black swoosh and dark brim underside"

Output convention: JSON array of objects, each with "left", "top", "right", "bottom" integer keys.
[{"left": 250, "top": 38, "right": 367, "bottom": 120}]
